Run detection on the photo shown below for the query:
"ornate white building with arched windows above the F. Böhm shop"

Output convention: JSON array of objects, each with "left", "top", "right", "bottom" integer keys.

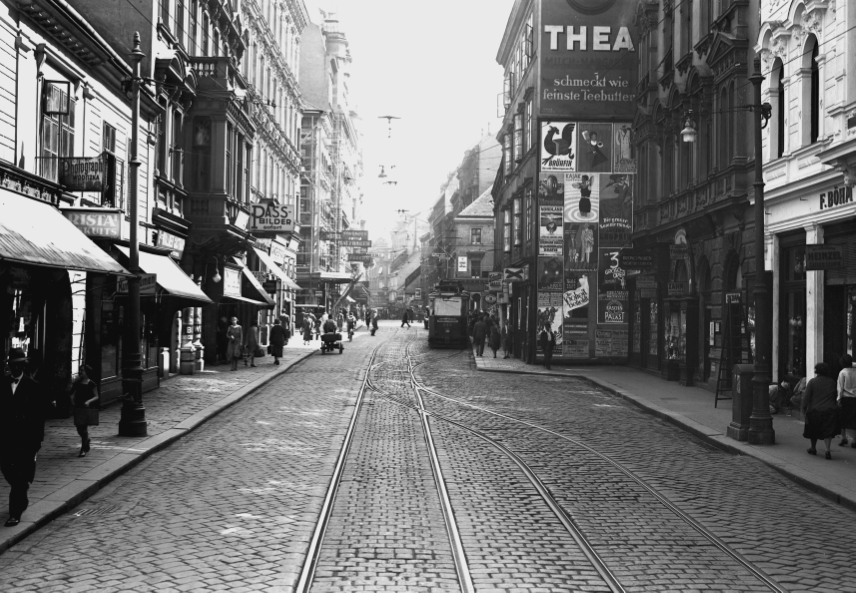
[{"left": 752, "top": 2, "right": 856, "bottom": 380}]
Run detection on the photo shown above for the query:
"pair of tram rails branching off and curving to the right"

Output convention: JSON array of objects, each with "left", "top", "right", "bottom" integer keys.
[{"left": 405, "top": 343, "right": 787, "bottom": 593}]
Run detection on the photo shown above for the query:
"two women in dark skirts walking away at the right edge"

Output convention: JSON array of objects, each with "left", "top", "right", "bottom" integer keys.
[{"left": 801, "top": 354, "right": 856, "bottom": 459}]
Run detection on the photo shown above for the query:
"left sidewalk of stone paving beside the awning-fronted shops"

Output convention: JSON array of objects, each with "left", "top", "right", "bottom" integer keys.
[{"left": 0, "top": 338, "right": 317, "bottom": 552}]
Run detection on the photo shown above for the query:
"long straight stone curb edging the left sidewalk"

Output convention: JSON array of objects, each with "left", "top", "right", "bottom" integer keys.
[{"left": 0, "top": 349, "right": 316, "bottom": 554}]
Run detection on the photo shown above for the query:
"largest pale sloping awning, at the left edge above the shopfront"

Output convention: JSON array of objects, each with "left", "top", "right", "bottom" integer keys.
[{"left": 0, "top": 189, "right": 131, "bottom": 276}]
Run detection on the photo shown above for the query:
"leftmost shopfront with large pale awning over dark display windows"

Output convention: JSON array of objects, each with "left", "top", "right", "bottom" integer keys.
[{"left": 0, "top": 183, "right": 130, "bottom": 414}]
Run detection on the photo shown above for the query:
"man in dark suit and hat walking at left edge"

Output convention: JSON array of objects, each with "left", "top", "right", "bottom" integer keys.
[{"left": 0, "top": 348, "right": 49, "bottom": 527}]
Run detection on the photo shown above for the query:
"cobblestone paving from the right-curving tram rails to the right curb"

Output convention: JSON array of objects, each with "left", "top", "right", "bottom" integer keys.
[{"left": 417, "top": 345, "right": 856, "bottom": 591}]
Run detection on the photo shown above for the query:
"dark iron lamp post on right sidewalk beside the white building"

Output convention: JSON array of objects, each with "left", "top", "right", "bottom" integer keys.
[{"left": 749, "top": 57, "right": 776, "bottom": 445}]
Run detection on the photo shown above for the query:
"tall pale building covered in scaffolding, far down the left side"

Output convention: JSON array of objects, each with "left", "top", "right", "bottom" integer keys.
[{"left": 297, "top": 12, "right": 368, "bottom": 320}]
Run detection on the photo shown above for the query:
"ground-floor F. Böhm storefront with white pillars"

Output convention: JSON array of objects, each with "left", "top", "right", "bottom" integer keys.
[{"left": 767, "top": 177, "right": 856, "bottom": 381}]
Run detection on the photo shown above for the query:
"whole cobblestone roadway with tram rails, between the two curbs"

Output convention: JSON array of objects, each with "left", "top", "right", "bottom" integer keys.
[{"left": 0, "top": 322, "right": 856, "bottom": 593}]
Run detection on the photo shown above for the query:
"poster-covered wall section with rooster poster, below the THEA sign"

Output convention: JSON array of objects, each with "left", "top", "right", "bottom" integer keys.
[{"left": 536, "top": 115, "right": 636, "bottom": 359}]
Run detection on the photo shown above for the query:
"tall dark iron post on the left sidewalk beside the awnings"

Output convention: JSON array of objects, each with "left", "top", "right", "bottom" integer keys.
[{"left": 119, "top": 32, "right": 148, "bottom": 437}]
